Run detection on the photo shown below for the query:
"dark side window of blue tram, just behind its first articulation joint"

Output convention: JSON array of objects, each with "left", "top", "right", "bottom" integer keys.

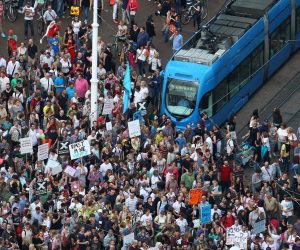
[{"left": 270, "top": 18, "right": 291, "bottom": 58}]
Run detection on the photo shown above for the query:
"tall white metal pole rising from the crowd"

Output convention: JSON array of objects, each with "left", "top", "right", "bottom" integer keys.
[{"left": 90, "top": 0, "right": 99, "bottom": 126}]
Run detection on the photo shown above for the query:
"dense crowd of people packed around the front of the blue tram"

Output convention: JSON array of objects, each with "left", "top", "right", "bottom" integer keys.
[{"left": 0, "top": 0, "right": 300, "bottom": 250}]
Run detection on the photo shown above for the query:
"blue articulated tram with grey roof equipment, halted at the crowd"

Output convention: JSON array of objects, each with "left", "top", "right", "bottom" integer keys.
[{"left": 161, "top": 0, "right": 300, "bottom": 129}]
